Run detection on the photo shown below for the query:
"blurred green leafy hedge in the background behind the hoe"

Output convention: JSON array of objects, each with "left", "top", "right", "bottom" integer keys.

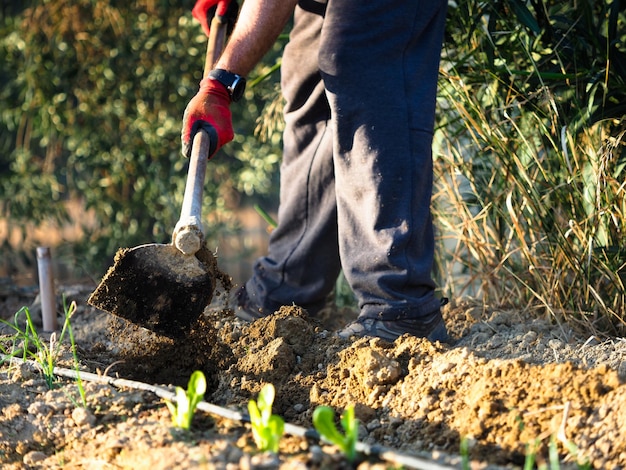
[{"left": 0, "top": 0, "right": 281, "bottom": 274}]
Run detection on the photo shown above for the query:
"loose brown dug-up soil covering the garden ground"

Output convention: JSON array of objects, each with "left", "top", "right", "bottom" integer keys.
[{"left": 0, "top": 278, "right": 626, "bottom": 470}]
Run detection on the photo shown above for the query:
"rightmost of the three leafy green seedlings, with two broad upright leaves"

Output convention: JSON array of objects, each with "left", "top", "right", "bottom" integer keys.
[{"left": 313, "top": 405, "right": 359, "bottom": 462}]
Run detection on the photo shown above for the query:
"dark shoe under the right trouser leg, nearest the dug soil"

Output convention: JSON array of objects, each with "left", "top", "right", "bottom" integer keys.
[{"left": 337, "top": 313, "right": 450, "bottom": 343}]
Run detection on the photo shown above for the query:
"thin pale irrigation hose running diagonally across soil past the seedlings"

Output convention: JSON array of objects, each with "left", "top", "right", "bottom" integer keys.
[{"left": 0, "top": 354, "right": 454, "bottom": 470}]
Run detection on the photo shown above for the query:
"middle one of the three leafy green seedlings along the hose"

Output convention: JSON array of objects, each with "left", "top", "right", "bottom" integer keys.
[{"left": 248, "top": 384, "right": 285, "bottom": 453}]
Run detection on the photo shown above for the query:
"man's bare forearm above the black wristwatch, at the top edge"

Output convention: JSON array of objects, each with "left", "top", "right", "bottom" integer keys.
[{"left": 215, "top": 0, "right": 297, "bottom": 76}]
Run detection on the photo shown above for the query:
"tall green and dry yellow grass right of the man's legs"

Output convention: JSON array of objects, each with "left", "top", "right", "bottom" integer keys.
[{"left": 434, "top": 2, "right": 626, "bottom": 335}]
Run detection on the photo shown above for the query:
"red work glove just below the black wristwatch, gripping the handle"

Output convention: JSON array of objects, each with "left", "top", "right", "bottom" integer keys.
[{"left": 181, "top": 78, "right": 234, "bottom": 158}]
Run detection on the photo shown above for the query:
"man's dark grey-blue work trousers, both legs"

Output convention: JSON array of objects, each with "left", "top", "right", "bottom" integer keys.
[{"left": 246, "top": 0, "right": 447, "bottom": 320}]
